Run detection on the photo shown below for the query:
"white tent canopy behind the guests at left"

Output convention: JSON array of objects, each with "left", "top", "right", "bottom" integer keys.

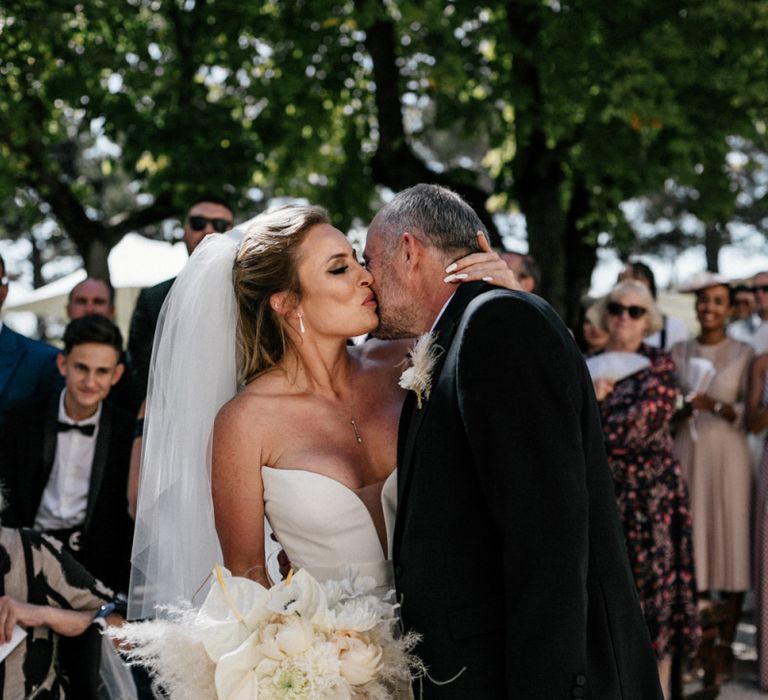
[{"left": 3, "top": 233, "right": 187, "bottom": 333}]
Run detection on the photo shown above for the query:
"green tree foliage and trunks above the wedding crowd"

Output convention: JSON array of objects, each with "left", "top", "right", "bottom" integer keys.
[{"left": 0, "top": 0, "right": 768, "bottom": 322}]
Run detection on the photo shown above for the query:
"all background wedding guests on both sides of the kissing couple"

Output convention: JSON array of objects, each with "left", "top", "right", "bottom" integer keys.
[{"left": 0, "top": 197, "right": 768, "bottom": 698}]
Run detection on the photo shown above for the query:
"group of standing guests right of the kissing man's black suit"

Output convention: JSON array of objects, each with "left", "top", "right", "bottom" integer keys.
[{"left": 576, "top": 262, "right": 768, "bottom": 690}]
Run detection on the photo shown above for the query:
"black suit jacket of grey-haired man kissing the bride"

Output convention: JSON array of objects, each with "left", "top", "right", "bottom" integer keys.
[{"left": 393, "top": 283, "right": 661, "bottom": 700}]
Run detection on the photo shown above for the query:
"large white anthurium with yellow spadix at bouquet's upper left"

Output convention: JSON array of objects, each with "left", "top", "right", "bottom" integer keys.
[{"left": 198, "top": 569, "right": 271, "bottom": 662}]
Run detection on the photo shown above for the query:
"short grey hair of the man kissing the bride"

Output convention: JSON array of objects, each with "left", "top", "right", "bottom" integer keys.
[{"left": 376, "top": 184, "right": 488, "bottom": 252}]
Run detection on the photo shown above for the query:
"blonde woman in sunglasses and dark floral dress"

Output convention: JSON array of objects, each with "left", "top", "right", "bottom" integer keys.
[{"left": 595, "top": 280, "right": 700, "bottom": 695}]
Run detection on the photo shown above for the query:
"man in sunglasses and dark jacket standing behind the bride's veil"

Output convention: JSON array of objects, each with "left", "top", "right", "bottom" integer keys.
[{"left": 128, "top": 196, "right": 235, "bottom": 405}]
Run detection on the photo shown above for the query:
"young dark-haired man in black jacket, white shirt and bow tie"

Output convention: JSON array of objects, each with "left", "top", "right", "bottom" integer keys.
[{"left": 0, "top": 315, "right": 133, "bottom": 591}]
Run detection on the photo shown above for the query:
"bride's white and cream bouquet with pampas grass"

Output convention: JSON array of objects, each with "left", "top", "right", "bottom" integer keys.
[{"left": 111, "top": 567, "right": 421, "bottom": 700}]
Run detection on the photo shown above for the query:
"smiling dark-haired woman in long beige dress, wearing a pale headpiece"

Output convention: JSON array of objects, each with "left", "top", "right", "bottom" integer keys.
[{"left": 672, "top": 273, "right": 753, "bottom": 680}]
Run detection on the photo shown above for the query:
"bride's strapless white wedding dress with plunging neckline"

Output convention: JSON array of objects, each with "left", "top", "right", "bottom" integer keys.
[{"left": 261, "top": 466, "right": 397, "bottom": 595}]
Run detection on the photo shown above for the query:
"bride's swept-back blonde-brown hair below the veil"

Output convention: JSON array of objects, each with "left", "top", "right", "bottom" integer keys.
[{"left": 233, "top": 204, "right": 331, "bottom": 384}]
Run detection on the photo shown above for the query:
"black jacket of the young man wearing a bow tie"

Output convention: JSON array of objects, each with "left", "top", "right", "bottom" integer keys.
[{"left": 0, "top": 393, "right": 135, "bottom": 592}]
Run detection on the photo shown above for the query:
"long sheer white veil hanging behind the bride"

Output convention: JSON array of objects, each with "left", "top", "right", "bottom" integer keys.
[{"left": 128, "top": 228, "right": 244, "bottom": 619}]
